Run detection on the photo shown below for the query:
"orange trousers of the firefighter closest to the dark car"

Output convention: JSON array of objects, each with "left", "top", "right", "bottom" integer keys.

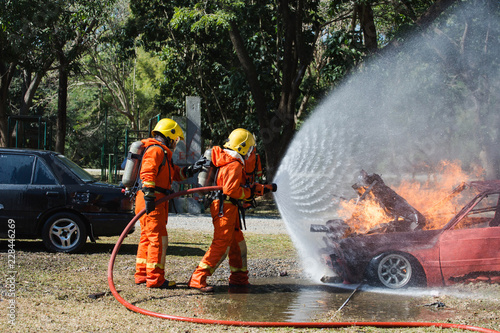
[{"left": 134, "top": 191, "right": 168, "bottom": 288}]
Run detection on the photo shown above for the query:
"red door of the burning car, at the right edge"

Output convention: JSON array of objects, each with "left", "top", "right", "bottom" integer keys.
[{"left": 439, "top": 194, "right": 500, "bottom": 284}]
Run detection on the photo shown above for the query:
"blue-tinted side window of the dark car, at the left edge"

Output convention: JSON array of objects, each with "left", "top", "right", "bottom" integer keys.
[{"left": 0, "top": 154, "right": 35, "bottom": 185}]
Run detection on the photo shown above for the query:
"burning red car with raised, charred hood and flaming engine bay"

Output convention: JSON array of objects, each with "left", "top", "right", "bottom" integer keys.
[{"left": 311, "top": 171, "right": 500, "bottom": 289}]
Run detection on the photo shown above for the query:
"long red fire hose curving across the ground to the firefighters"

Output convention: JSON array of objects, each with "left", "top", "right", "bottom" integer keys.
[{"left": 108, "top": 186, "right": 500, "bottom": 333}]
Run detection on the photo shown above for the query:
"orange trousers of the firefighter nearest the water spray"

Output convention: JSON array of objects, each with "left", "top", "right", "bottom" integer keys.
[{"left": 189, "top": 200, "right": 249, "bottom": 288}]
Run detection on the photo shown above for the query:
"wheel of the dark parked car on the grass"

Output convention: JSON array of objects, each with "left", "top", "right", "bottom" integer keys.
[{"left": 42, "top": 213, "right": 87, "bottom": 253}]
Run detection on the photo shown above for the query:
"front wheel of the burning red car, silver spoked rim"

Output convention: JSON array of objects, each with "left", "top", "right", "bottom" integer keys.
[{"left": 368, "top": 252, "right": 423, "bottom": 289}]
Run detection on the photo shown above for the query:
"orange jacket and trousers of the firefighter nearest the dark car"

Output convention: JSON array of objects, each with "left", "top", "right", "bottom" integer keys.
[{"left": 134, "top": 138, "right": 186, "bottom": 288}]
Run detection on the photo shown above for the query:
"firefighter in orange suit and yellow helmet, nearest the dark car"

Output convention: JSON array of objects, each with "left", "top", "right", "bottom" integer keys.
[{"left": 134, "top": 118, "right": 202, "bottom": 289}]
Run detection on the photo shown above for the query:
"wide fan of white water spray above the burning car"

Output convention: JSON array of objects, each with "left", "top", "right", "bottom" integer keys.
[{"left": 274, "top": 0, "right": 500, "bottom": 279}]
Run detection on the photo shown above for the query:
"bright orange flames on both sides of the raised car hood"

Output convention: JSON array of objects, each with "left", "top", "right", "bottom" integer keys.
[{"left": 337, "top": 161, "right": 483, "bottom": 233}]
